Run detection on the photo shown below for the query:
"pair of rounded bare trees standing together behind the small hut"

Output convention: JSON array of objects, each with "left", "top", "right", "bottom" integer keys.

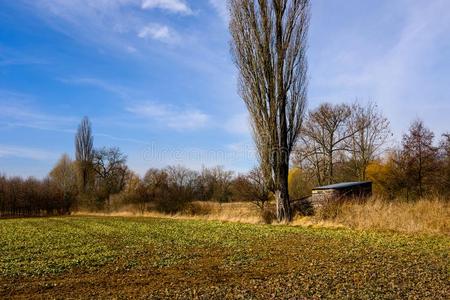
[{"left": 294, "top": 102, "right": 391, "bottom": 185}]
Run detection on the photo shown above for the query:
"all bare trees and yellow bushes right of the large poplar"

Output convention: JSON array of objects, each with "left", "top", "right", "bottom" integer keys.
[{"left": 289, "top": 103, "right": 450, "bottom": 200}]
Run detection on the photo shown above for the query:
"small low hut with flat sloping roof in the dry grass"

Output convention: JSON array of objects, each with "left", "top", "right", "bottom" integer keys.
[{"left": 310, "top": 181, "right": 372, "bottom": 207}]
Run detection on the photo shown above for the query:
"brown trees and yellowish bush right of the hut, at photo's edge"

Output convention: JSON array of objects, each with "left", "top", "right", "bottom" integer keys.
[{"left": 376, "top": 120, "right": 450, "bottom": 200}]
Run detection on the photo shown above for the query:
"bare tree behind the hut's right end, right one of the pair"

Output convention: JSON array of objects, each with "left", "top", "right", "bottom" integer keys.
[{"left": 347, "top": 102, "right": 390, "bottom": 180}]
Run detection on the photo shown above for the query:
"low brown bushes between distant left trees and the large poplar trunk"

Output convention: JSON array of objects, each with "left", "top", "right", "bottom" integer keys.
[{"left": 118, "top": 166, "right": 269, "bottom": 213}]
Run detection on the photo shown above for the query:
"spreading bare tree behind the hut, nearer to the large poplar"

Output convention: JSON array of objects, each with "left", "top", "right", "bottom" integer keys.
[{"left": 299, "top": 103, "right": 361, "bottom": 184}]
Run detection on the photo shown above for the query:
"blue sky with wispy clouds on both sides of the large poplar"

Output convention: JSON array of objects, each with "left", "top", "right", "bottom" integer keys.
[{"left": 0, "top": 0, "right": 450, "bottom": 177}]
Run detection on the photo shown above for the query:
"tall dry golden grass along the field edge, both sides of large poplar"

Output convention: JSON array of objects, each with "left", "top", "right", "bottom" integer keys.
[{"left": 75, "top": 198, "right": 450, "bottom": 235}]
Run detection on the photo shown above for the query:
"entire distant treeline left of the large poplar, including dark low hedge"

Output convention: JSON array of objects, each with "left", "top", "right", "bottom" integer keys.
[{"left": 0, "top": 118, "right": 269, "bottom": 216}]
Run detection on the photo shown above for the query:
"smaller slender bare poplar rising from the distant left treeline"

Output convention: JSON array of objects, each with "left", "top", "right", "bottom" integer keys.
[{"left": 75, "top": 117, "right": 94, "bottom": 193}]
